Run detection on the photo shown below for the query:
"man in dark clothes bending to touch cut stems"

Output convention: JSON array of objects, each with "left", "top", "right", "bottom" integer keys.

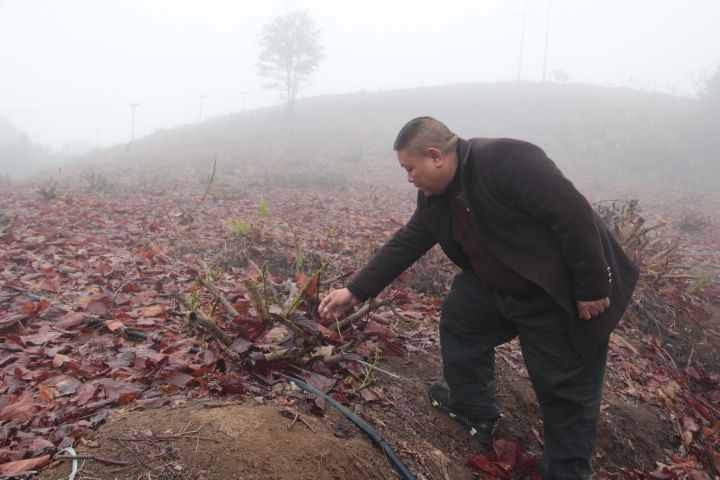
[{"left": 320, "top": 117, "right": 638, "bottom": 479}]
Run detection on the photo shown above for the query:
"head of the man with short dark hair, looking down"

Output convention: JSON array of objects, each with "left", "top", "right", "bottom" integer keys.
[{"left": 393, "top": 117, "right": 458, "bottom": 196}]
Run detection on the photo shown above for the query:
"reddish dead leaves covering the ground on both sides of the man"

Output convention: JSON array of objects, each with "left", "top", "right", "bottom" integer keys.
[{"left": 0, "top": 182, "right": 720, "bottom": 479}]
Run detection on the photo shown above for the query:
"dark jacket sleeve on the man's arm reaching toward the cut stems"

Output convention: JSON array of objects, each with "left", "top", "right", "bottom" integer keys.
[{"left": 347, "top": 201, "right": 436, "bottom": 301}]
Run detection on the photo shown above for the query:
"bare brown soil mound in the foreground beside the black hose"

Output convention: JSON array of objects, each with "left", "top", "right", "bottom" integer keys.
[{"left": 40, "top": 402, "right": 395, "bottom": 480}]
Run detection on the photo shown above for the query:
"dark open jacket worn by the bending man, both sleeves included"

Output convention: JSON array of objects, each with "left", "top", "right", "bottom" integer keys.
[{"left": 348, "top": 138, "right": 638, "bottom": 344}]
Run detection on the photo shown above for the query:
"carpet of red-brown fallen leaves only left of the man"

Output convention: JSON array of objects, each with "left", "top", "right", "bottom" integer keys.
[{"left": 0, "top": 183, "right": 435, "bottom": 474}]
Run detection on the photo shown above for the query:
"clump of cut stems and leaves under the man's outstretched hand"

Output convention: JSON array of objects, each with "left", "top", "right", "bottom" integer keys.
[{"left": 174, "top": 268, "right": 400, "bottom": 365}]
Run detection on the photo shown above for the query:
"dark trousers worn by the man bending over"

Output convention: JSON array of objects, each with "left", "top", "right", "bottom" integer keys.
[{"left": 440, "top": 272, "right": 607, "bottom": 479}]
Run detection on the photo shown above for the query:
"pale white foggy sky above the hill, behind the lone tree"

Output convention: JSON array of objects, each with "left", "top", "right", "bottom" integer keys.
[{"left": 0, "top": 0, "right": 720, "bottom": 152}]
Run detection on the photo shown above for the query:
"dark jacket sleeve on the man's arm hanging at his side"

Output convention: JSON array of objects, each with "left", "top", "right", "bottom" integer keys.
[{"left": 493, "top": 142, "right": 610, "bottom": 301}]
